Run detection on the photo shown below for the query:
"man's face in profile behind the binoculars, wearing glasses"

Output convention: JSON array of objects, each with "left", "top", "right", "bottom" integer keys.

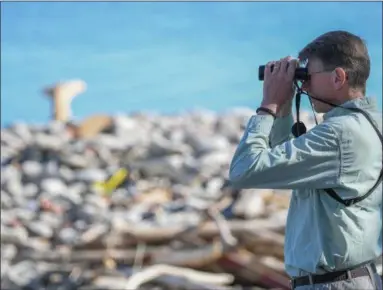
[{"left": 302, "top": 59, "right": 335, "bottom": 113}]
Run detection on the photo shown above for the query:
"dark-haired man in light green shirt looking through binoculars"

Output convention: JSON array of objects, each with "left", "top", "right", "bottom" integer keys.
[{"left": 230, "top": 31, "right": 382, "bottom": 290}]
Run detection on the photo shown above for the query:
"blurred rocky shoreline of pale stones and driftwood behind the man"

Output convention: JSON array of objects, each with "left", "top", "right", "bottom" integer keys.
[{"left": 1, "top": 108, "right": 380, "bottom": 290}]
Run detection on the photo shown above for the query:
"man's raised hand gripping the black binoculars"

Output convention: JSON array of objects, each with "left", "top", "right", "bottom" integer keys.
[{"left": 261, "top": 56, "right": 298, "bottom": 115}]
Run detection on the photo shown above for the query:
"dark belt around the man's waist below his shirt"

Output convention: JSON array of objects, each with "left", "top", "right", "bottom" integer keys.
[{"left": 291, "top": 263, "right": 377, "bottom": 289}]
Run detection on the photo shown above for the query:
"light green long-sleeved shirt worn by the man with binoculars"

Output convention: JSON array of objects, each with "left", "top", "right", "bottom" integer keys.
[{"left": 230, "top": 98, "right": 382, "bottom": 276}]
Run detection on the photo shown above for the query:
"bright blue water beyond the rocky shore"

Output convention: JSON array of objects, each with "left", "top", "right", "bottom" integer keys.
[{"left": 1, "top": 2, "right": 383, "bottom": 126}]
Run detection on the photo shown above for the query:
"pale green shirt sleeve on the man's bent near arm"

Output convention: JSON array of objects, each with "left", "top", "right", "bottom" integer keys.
[{"left": 229, "top": 115, "right": 340, "bottom": 189}]
